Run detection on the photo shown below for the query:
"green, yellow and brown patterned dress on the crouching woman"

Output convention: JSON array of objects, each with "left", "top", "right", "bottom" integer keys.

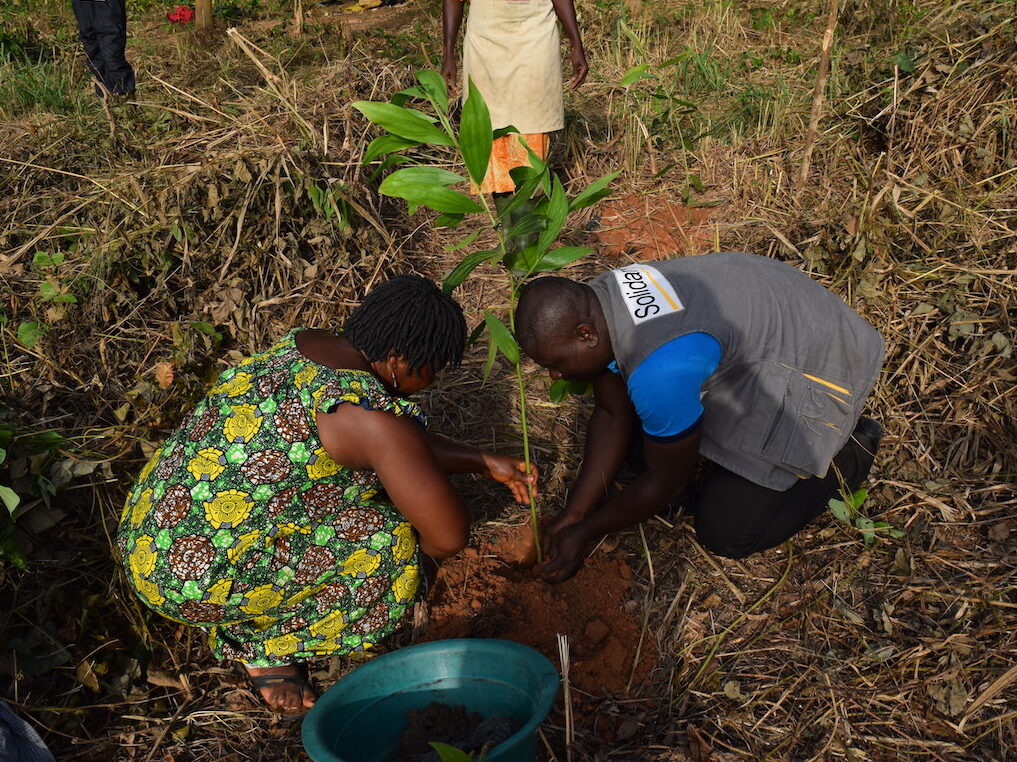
[{"left": 117, "top": 329, "right": 424, "bottom": 666}]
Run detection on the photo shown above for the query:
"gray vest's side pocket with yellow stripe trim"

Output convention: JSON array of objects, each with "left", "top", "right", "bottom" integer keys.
[{"left": 741, "top": 362, "right": 854, "bottom": 477}]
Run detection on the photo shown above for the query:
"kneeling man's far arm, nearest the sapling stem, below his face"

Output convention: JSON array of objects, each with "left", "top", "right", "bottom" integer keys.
[{"left": 548, "top": 372, "right": 639, "bottom": 534}]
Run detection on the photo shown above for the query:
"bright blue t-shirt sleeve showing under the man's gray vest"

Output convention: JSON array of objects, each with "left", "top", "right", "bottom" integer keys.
[{"left": 609, "top": 333, "right": 722, "bottom": 442}]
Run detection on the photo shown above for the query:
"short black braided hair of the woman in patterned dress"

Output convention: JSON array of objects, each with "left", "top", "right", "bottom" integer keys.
[{"left": 343, "top": 275, "right": 466, "bottom": 374}]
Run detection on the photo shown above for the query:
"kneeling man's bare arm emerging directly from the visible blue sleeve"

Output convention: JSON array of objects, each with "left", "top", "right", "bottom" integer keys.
[{"left": 543, "top": 427, "right": 703, "bottom": 582}]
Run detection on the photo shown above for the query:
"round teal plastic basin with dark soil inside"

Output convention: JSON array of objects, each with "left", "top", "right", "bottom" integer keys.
[{"left": 301, "top": 638, "right": 558, "bottom": 762}]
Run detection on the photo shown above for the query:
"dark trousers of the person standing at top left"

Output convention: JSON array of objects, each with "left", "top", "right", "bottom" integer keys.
[{"left": 71, "top": 0, "right": 135, "bottom": 96}]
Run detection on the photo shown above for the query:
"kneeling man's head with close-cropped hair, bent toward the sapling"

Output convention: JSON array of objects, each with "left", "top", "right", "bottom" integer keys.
[{"left": 516, "top": 277, "right": 614, "bottom": 382}]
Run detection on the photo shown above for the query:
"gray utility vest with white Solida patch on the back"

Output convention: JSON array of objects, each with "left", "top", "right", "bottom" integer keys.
[{"left": 589, "top": 253, "right": 884, "bottom": 491}]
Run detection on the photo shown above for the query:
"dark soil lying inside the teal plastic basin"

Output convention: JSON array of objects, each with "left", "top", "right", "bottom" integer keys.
[{"left": 387, "top": 701, "right": 523, "bottom": 762}]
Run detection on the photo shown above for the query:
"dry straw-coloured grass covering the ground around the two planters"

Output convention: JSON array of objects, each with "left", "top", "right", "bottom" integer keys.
[{"left": 0, "top": 0, "right": 1017, "bottom": 762}]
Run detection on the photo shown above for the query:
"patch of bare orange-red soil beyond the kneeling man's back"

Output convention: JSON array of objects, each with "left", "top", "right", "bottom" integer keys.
[{"left": 595, "top": 195, "right": 713, "bottom": 261}]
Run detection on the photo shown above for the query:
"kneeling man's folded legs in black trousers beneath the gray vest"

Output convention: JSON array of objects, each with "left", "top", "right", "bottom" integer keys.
[{"left": 690, "top": 418, "right": 883, "bottom": 559}]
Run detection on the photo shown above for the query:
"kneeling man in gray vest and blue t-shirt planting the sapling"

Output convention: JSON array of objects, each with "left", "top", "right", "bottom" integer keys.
[{"left": 516, "top": 253, "right": 884, "bottom": 581}]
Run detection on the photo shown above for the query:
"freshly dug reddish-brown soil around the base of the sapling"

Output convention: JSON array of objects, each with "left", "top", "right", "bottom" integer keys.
[{"left": 424, "top": 526, "right": 657, "bottom": 696}]
